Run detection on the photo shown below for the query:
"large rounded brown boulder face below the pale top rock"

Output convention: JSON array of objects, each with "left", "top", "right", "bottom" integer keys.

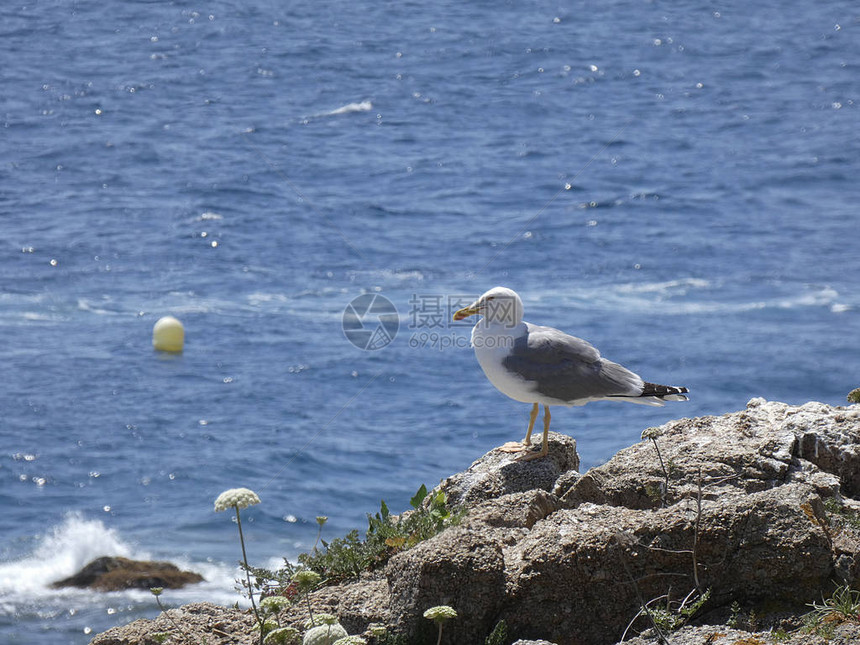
[{"left": 502, "top": 489, "right": 832, "bottom": 645}]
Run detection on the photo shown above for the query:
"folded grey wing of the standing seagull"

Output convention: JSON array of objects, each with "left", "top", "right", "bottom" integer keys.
[{"left": 502, "top": 323, "right": 643, "bottom": 402}]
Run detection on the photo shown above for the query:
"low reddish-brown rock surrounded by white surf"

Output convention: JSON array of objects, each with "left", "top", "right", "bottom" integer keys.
[{"left": 51, "top": 556, "right": 203, "bottom": 591}]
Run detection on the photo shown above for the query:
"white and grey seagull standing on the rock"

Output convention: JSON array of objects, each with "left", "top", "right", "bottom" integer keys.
[{"left": 454, "top": 287, "right": 688, "bottom": 461}]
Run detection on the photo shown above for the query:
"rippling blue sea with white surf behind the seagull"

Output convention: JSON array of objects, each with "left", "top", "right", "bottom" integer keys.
[{"left": 0, "top": 0, "right": 860, "bottom": 645}]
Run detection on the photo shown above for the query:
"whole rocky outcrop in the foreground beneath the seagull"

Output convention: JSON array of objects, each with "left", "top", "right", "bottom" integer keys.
[{"left": 93, "top": 399, "right": 860, "bottom": 645}]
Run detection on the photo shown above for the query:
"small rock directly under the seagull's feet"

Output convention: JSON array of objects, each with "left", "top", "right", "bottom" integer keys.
[{"left": 440, "top": 432, "right": 579, "bottom": 506}]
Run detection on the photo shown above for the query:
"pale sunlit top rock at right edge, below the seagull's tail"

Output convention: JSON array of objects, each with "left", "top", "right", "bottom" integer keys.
[{"left": 561, "top": 399, "right": 860, "bottom": 509}]
